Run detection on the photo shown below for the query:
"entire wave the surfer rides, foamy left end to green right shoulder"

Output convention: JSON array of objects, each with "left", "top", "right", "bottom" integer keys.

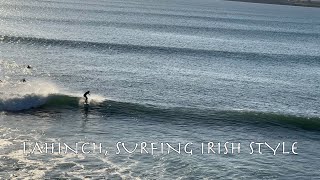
[{"left": 0, "top": 90, "right": 320, "bottom": 131}]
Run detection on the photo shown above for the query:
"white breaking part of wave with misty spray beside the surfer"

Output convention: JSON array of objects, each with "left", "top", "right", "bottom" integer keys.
[{"left": 0, "top": 80, "right": 104, "bottom": 111}]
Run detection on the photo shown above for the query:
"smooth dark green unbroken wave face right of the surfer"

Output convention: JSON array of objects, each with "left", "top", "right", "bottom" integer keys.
[{"left": 97, "top": 101, "right": 320, "bottom": 131}]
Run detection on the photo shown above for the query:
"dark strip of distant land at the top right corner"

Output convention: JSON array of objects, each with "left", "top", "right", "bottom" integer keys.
[{"left": 227, "top": 0, "right": 320, "bottom": 7}]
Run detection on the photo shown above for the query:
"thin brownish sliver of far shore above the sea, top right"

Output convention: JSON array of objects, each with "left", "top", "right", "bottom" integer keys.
[{"left": 226, "top": 0, "right": 320, "bottom": 8}]
